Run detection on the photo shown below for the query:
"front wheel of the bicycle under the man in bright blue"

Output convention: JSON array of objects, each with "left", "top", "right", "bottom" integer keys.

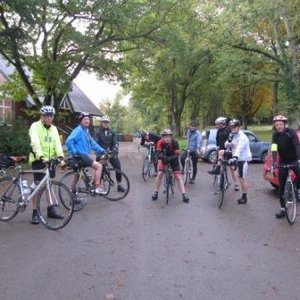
[{"left": 102, "top": 168, "right": 130, "bottom": 201}]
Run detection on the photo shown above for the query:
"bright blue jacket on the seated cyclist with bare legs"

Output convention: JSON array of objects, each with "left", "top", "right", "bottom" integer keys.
[{"left": 66, "top": 125, "right": 106, "bottom": 156}]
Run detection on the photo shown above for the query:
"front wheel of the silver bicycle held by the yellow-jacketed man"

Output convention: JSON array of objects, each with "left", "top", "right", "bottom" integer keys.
[{"left": 37, "top": 180, "right": 74, "bottom": 230}]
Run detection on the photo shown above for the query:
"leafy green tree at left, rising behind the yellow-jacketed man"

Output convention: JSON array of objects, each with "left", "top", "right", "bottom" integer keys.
[{"left": 0, "top": 0, "right": 176, "bottom": 113}]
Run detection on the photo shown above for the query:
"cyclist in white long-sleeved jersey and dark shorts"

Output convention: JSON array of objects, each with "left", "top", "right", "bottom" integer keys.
[{"left": 225, "top": 119, "right": 252, "bottom": 204}]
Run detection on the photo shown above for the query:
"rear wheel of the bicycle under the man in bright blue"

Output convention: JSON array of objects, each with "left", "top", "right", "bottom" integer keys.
[{"left": 60, "top": 171, "right": 90, "bottom": 211}]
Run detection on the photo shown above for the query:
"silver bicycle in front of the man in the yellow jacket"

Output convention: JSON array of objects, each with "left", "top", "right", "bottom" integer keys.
[{"left": 0, "top": 159, "right": 74, "bottom": 230}]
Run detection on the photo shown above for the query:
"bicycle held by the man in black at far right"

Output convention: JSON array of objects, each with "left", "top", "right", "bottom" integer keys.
[{"left": 275, "top": 164, "right": 298, "bottom": 225}]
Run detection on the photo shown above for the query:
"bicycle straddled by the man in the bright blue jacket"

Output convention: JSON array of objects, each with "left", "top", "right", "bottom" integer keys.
[{"left": 61, "top": 153, "right": 130, "bottom": 211}]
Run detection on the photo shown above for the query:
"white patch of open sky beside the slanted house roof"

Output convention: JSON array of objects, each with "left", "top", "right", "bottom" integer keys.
[{"left": 75, "top": 72, "right": 126, "bottom": 105}]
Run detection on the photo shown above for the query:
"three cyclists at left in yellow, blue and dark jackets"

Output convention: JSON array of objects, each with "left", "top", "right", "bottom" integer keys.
[{"left": 29, "top": 106, "right": 125, "bottom": 224}]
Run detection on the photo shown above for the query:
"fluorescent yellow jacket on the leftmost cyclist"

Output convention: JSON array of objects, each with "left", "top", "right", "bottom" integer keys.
[{"left": 29, "top": 120, "right": 64, "bottom": 163}]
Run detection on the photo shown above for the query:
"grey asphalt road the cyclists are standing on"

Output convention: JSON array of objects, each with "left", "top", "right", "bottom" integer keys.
[{"left": 0, "top": 142, "right": 300, "bottom": 300}]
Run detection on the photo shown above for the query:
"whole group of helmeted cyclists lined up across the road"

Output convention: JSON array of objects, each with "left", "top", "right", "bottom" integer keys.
[{"left": 14, "top": 106, "right": 300, "bottom": 224}]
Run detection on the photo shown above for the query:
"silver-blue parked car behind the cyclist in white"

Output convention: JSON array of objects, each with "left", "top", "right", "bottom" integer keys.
[{"left": 200, "top": 128, "right": 270, "bottom": 163}]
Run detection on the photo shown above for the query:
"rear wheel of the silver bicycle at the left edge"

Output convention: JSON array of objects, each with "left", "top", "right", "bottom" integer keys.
[{"left": 0, "top": 177, "right": 21, "bottom": 221}]
